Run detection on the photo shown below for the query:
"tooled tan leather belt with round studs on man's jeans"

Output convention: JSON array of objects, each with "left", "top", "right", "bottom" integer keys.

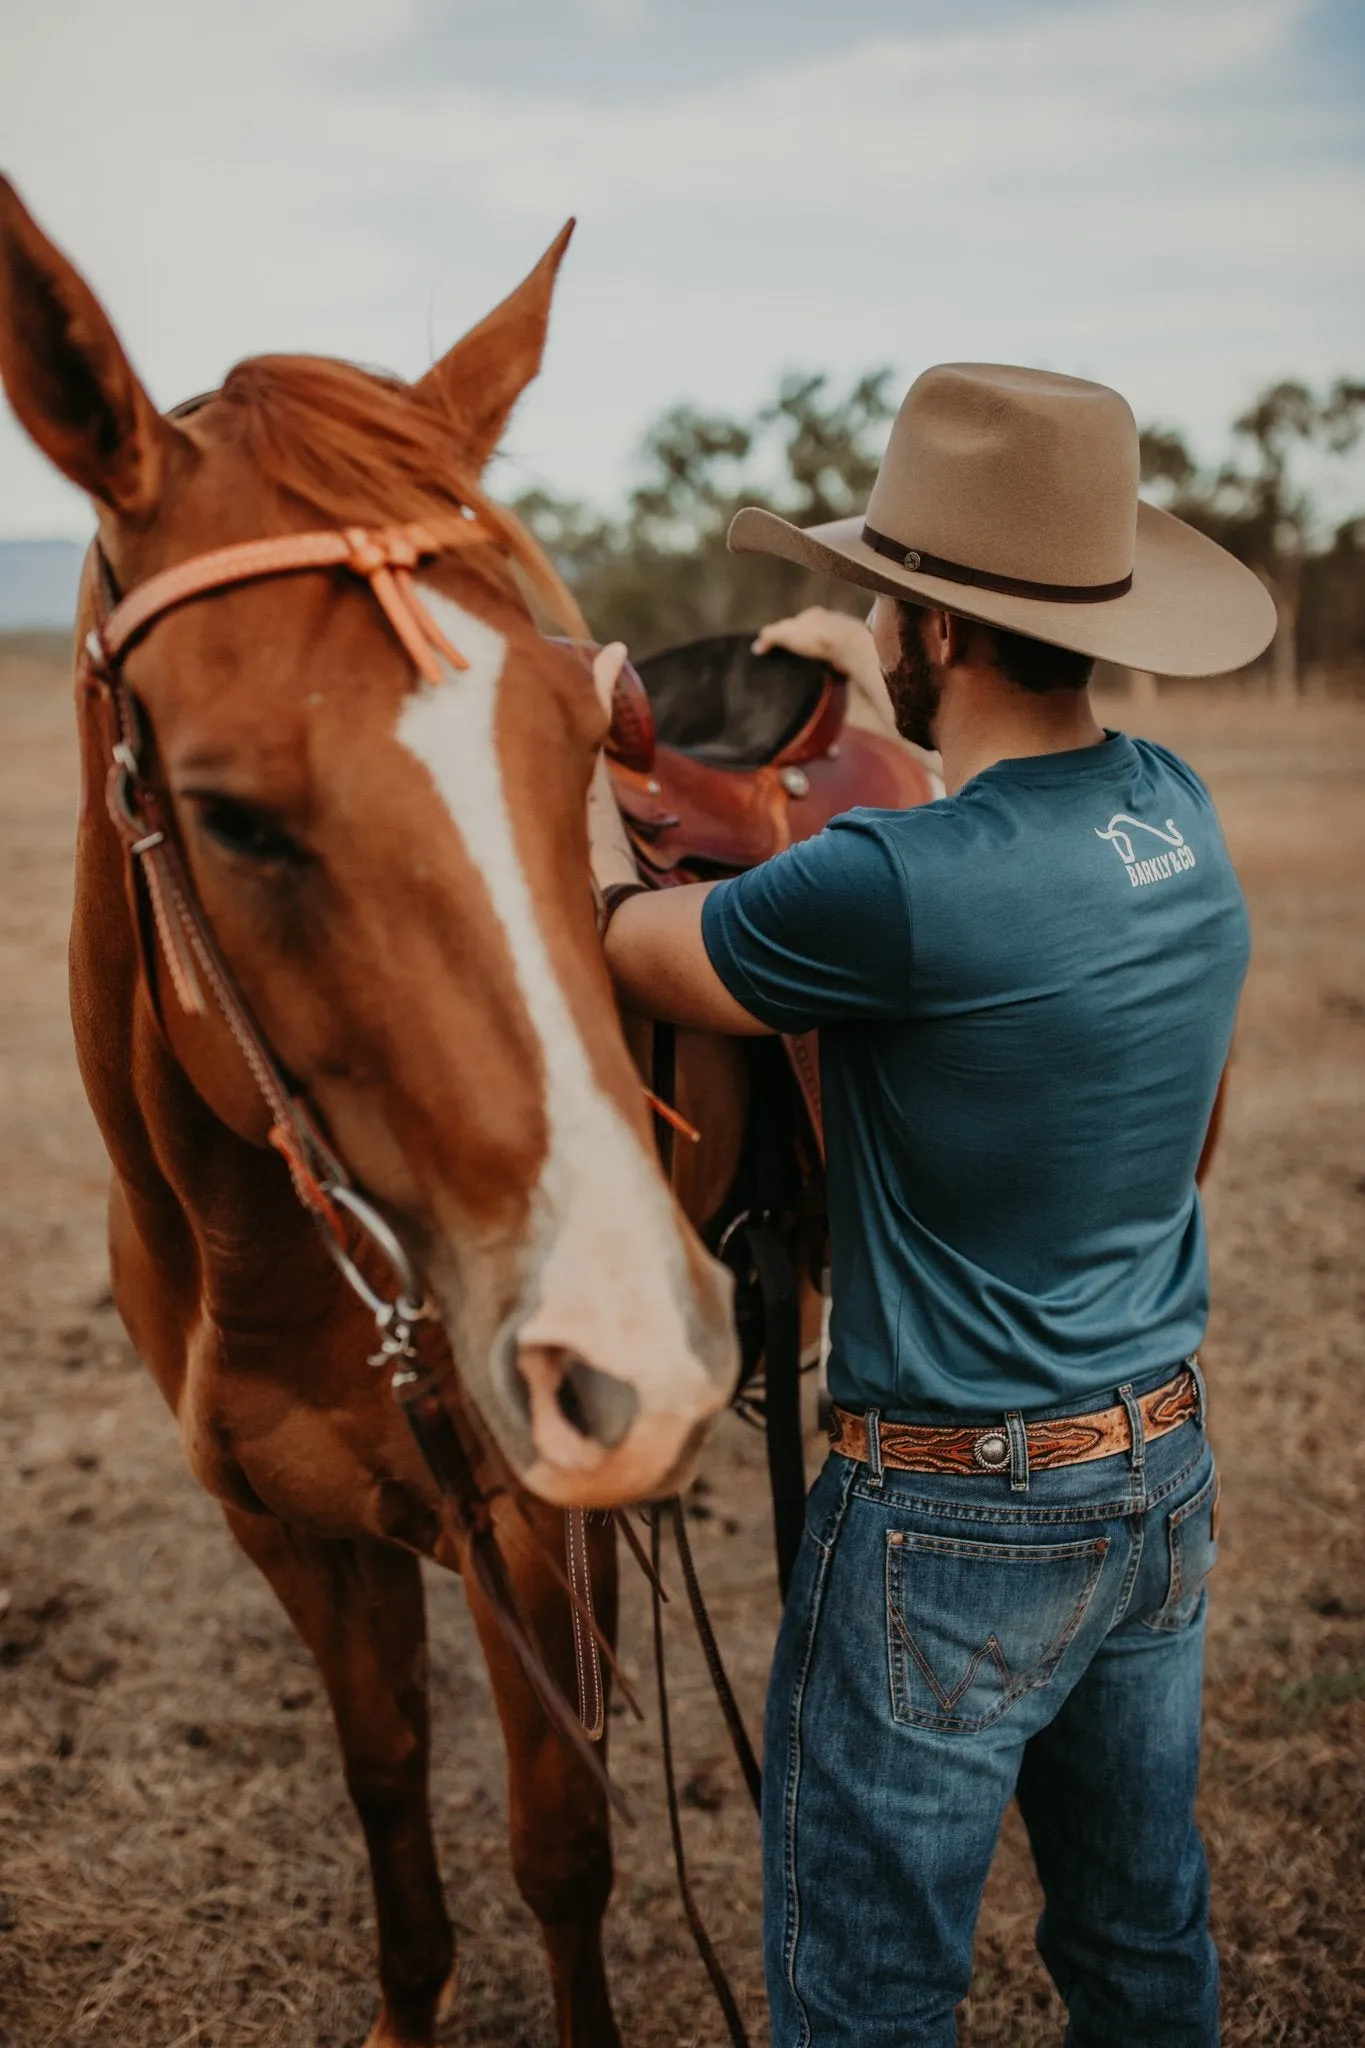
[{"left": 829, "top": 1366, "right": 1199, "bottom": 1475}]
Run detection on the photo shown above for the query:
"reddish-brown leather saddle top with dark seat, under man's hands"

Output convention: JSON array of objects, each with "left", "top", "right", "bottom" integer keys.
[{"left": 606, "top": 633, "right": 935, "bottom": 885}]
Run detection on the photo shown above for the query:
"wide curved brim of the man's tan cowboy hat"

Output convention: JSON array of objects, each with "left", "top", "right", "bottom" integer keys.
[{"left": 729, "top": 502, "right": 1277, "bottom": 676}]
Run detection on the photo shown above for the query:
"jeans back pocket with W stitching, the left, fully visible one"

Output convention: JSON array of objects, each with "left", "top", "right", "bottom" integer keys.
[{"left": 886, "top": 1530, "right": 1109, "bottom": 1733}]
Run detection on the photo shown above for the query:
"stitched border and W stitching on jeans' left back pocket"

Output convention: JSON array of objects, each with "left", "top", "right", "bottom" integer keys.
[{"left": 886, "top": 1530, "right": 1109, "bottom": 1735}]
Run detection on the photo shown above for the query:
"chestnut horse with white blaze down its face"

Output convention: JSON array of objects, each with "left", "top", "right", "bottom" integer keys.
[{"left": 0, "top": 180, "right": 753, "bottom": 2048}]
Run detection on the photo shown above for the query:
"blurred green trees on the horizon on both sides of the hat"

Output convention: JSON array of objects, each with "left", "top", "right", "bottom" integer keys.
[{"left": 514, "top": 371, "right": 1365, "bottom": 690}]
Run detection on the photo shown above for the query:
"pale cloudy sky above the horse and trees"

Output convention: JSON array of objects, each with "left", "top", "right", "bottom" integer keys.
[{"left": 0, "top": 0, "right": 1365, "bottom": 539}]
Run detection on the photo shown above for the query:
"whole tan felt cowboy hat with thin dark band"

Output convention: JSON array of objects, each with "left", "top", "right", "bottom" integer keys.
[{"left": 731, "top": 362, "right": 1275, "bottom": 676}]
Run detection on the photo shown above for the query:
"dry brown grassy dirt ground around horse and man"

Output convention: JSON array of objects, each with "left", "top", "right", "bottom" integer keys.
[{"left": 0, "top": 647, "right": 1365, "bottom": 2048}]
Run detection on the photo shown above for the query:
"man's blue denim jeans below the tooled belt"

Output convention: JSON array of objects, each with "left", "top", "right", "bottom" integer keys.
[{"left": 763, "top": 1374, "right": 1218, "bottom": 2048}]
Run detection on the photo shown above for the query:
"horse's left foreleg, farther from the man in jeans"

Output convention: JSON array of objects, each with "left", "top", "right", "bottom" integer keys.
[{"left": 227, "top": 1507, "right": 454, "bottom": 2048}]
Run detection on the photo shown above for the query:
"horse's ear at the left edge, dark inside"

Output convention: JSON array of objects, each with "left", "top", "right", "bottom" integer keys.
[{"left": 0, "top": 178, "right": 172, "bottom": 520}]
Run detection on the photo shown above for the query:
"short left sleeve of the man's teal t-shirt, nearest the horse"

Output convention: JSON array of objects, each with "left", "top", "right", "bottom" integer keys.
[{"left": 702, "top": 811, "right": 913, "bottom": 1032}]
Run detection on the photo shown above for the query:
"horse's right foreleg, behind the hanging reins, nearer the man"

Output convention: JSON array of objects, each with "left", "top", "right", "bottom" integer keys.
[{"left": 469, "top": 1497, "right": 620, "bottom": 2048}]
